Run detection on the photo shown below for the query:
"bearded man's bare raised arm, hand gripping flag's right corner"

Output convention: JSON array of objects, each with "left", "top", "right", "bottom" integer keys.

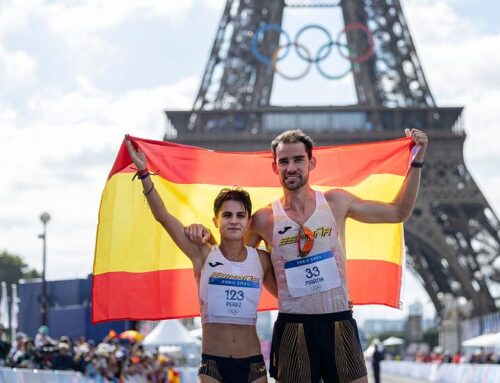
[{"left": 327, "top": 129, "right": 428, "bottom": 223}]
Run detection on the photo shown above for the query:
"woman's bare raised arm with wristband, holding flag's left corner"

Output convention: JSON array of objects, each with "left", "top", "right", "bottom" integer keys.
[{"left": 125, "top": 137, "right": 210, "bottom": 270}]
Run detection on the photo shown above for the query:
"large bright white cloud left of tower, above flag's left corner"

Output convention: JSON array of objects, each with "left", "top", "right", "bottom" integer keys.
[{"left": 0, "top": 75, "right": 197, "bottom": 182}]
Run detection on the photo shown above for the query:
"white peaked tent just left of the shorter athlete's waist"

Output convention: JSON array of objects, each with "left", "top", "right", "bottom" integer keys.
[{"left": 142, "top": 319, "right": 200, "bottom": 348}]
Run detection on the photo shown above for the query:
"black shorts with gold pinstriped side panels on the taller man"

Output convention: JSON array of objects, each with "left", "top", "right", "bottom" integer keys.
[{"left": 269, "top": 311, "right": 367, "bottom": 383}]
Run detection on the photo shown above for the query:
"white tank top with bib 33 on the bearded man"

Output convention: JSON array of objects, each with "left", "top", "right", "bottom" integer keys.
[{"left": 271, "top": 191, "right": 349, "bottom": 314}]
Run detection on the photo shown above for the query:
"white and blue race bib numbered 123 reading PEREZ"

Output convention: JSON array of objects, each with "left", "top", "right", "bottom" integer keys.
[{"left": 207, "top": 277, "right": 260, "bottom": 319}]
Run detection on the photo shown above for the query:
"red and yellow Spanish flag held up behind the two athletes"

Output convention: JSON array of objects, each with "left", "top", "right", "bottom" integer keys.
[{"left": 92, "top": 137, "right": 413, "bottom": 323}]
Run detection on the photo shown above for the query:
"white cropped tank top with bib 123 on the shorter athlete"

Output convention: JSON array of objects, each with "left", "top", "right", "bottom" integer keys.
[{"left": 199, "top": 246, "right": 264, "bottom": 325}]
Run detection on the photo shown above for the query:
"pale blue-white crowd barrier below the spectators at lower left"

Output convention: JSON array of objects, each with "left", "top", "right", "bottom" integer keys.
[{"left": 0, "top": 367, "right": 198, "bottom": 383}]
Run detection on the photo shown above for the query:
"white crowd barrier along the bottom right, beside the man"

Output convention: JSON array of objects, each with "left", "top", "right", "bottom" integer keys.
[{"left": 380, "top": 360, "right": 500, "bottom": 383}]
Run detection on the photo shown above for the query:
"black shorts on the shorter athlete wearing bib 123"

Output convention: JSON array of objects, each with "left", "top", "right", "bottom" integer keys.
[{"left": 198, "top": 354, "right": 267, "bottom": 383}]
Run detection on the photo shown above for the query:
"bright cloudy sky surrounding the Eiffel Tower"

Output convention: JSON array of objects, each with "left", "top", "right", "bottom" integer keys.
[{"left": 0, "top": 0, "right": 500, "bottom": 326}]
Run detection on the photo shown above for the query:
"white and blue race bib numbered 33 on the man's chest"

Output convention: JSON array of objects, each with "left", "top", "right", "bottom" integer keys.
[{"left": 285, "top": 251, "right": 340, "bottom": 297}]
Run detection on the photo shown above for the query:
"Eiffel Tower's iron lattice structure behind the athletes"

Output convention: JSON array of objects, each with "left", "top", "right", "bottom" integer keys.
[{"left": 165, "top": 0, "right": 500, "bottom": 316}]
